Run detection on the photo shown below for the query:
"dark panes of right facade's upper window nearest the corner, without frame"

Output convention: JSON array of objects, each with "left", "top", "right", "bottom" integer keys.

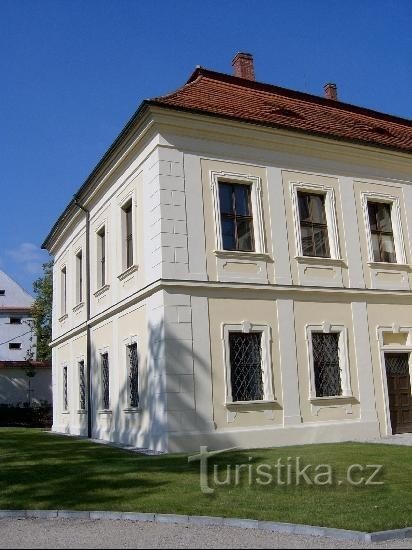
[{"left": 219, "top": 182, "right": 255, "bottom": 252}]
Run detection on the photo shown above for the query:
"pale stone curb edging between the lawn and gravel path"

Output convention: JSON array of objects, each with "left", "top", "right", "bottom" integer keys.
[{"left": 0, "top": 510, "right": 412, "bottom": 543}]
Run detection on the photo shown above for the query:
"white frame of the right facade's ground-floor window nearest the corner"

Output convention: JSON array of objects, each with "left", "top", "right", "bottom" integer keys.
[{"left": 222, "top": 321, "right": 275, "bottom": 405}]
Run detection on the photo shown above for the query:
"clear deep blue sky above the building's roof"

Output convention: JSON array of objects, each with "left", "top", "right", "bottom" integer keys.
[{"left": 0, "top": 0, "right": 412, "bottom": 291}]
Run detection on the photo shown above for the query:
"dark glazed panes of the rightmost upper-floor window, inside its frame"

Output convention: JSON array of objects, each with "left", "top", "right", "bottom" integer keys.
[{"left": 368, "top": 201, "right": 396, "bottom": 264}]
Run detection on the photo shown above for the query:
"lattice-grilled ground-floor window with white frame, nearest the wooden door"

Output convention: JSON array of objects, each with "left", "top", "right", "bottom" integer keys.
[{"left": 307, "top": 323, "right": 352, "bottom": 399}]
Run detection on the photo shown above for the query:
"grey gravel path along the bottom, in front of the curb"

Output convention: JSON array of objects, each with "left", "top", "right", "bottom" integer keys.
[{"left": 0, "top": 518, "right": 412, "bottom": 548}]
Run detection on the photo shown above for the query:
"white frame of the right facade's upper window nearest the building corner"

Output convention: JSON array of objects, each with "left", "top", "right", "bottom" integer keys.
[{"left": 210, "top": 170, "right": 266, "bottom": 255}]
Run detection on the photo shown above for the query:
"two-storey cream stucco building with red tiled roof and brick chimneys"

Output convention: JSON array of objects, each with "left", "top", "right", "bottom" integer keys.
[{"left": 44, "top": 54, "right": 412, "bottom": 452}]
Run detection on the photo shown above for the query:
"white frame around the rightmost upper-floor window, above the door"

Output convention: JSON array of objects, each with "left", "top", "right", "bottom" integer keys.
[{"left": 361, "top": 191, "right": 406, "bottom": 265}]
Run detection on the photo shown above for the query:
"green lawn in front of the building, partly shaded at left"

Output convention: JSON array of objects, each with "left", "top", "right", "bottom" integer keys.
[{"left": 0, "top": 428, "right": 412, "bottom": 531}]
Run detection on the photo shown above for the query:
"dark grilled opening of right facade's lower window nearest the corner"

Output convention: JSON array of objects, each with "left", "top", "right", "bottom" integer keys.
[{"left": 229, "top": 332, "right": 264, "bottom": 401}]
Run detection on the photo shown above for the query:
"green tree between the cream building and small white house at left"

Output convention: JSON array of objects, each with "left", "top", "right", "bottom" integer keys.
[{"left": 32, "top": 260, "right": 53, "bottom": 361}]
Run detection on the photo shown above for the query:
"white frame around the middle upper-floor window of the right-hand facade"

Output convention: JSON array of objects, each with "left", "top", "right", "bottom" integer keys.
[{"left": 290, "top": 182, "right": 341, "bottom": 262}]
